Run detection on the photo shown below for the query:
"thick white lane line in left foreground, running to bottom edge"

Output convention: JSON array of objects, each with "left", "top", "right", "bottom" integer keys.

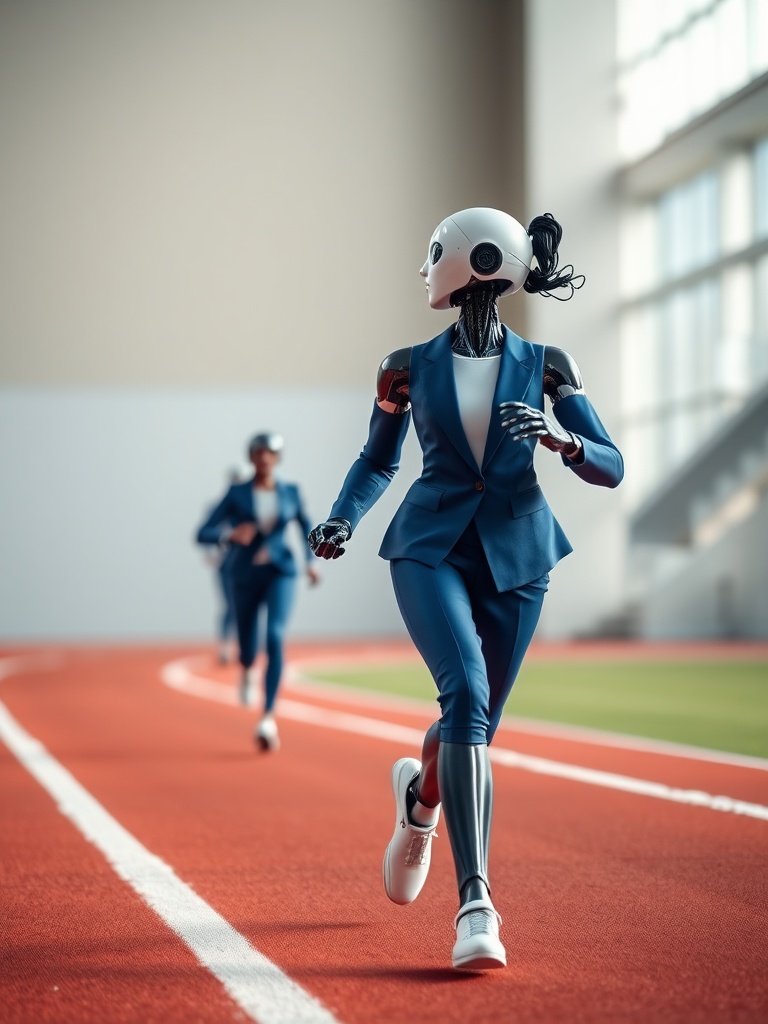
[{"left": 0, "top": 657, "right": 339, "bottom": 1024}]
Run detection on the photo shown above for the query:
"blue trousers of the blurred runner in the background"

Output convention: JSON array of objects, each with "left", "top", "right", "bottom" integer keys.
[{"left": 232, "top": 565, "right": 296, "bottom": 711}]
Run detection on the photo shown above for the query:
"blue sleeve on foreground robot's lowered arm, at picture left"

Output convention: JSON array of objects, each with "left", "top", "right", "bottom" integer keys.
[{"left": 329, "top": 401, "right": 411, "bottom": 531}]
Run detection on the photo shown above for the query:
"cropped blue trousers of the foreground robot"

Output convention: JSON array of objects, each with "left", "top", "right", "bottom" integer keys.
[{"left": 390, "top": 523, "right": 549, "bottom": 743}]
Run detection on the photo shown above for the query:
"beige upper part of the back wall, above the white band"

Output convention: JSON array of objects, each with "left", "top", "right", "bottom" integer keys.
[{"left": 0, "top": 0, "right": 523, "bottom": 388}]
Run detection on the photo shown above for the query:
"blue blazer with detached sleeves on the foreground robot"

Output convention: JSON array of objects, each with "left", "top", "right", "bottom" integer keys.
[{"left": 331, "top": 326, "right": 624, "bottom": 591}]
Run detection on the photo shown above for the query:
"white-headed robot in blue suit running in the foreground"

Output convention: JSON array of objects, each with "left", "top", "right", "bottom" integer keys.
[{"left": 309, "top": 208, "right": 624, "bottom": 971}]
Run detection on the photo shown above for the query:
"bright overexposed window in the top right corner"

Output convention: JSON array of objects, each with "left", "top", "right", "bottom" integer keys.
[{"left": 617, "top": 0, "right": 768, "bottom": 161}]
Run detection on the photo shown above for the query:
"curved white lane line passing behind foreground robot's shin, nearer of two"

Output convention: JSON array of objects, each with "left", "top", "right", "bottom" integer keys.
[{"left": 161, "top": 659, "right": 768, "bottom": 821}]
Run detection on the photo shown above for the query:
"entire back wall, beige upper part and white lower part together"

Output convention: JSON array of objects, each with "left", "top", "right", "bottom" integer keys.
[{"left": 0, "top": 0, "right": 557, "bottom": 640}]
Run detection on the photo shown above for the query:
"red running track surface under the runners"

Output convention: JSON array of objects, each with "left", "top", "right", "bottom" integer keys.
[{"left": 0, "top": 648, "right": 768, "bottom": 1024}]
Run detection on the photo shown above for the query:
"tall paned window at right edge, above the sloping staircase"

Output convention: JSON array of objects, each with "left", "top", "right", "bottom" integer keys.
[{"left": 622, "top": 142, "right": 768, "bottom": 502}]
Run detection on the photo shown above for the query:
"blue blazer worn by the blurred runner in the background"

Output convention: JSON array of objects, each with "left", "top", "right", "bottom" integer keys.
[{"left": 197, "top": 480, "right": 311, "bottom": 580}]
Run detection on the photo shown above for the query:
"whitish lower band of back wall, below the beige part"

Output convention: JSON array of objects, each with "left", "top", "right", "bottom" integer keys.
[{"left": 0, "top": 388, "right": 618, "bottom": 641}]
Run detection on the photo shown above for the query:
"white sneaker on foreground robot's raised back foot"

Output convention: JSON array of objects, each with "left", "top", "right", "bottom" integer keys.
[{"left": 382, "top": 758, "right": 440, "bottom": 904}]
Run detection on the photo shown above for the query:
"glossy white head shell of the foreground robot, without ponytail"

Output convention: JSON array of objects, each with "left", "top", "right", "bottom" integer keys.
[{"left": 419, "top": 207, "right": 534, "bottom": 309}]
